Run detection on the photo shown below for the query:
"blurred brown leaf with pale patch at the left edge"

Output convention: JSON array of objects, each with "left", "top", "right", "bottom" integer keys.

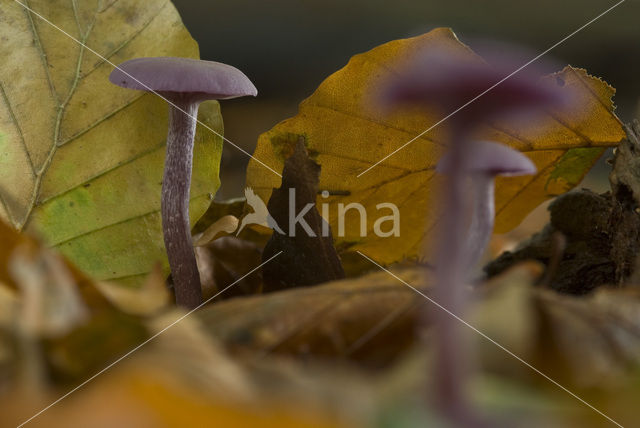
[{"left": 0, "top": 223, "right": 154, "bottom": 384}]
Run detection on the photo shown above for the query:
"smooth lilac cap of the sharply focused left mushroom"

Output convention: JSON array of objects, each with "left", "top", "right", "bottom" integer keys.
[{"left": 109, "top": 57, "right": 258, "bottom": 100}]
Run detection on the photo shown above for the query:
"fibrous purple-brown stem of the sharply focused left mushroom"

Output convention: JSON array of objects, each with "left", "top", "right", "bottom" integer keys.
[{"left": 162, "top": 96, "right": 202, "bottom": 309}]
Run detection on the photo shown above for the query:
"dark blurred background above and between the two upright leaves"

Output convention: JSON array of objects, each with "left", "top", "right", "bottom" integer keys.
[{"left": 174, "top": 0, "right": 640, "bottom": 198}]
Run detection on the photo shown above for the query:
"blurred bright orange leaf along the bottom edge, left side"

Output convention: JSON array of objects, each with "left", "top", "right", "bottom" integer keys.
[{"left": 0, "top": 361, "right": 350, "bottom": 428}]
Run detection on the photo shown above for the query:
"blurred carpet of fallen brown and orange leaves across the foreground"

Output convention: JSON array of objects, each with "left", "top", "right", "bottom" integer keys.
[{"left": 0, "top": 219, "right": 640, "bottom": 428}]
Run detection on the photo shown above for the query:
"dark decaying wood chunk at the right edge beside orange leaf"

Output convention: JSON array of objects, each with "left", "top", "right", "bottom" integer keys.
[{"left": 485, "top": 121, "right": 640, "bottom": 294}]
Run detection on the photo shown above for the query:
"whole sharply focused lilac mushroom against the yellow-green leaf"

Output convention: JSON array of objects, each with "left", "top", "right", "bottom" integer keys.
[{"left": 109, "top": 57, "right": 258, "bottom": 309}]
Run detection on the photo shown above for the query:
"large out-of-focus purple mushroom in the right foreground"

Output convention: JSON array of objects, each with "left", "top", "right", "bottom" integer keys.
[{"left": 381, "top": 50, "right": 569, "bottom": 426}]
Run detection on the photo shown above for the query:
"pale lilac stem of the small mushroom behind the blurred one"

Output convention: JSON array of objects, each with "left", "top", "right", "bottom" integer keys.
[{"left": 465, "top": 174, "right": 495, "bottom": 269}]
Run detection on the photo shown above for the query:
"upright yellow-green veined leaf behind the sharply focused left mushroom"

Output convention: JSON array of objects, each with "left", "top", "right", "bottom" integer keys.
[{"left": 0, "top": 0, "right": 222, "bottom": 284}]
